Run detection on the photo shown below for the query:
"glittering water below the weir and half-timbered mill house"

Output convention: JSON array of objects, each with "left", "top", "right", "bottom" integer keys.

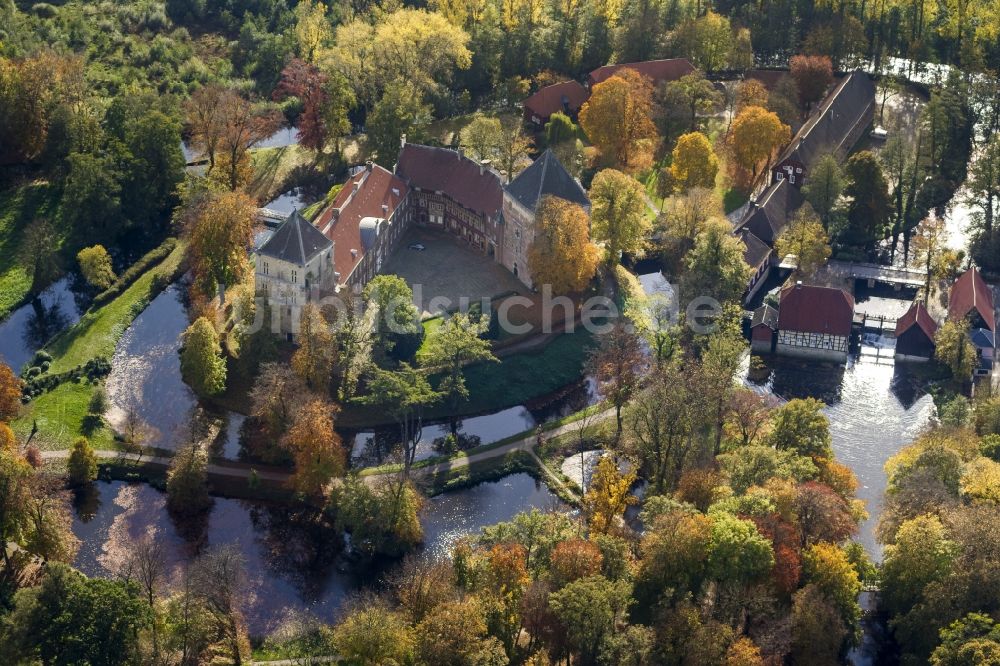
[{"left": 747, "top": 344, "right": 934, "bottom": 559}]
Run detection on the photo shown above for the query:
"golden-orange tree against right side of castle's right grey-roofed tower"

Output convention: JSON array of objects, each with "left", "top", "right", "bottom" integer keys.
[{"left": 528, "top": 197, "right": 601, "bottom": 294}]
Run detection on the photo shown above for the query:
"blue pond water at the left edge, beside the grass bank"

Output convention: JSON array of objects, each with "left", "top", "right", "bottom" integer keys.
[{"left": 0, "top": 277, "right": 83, "bottom": 372}]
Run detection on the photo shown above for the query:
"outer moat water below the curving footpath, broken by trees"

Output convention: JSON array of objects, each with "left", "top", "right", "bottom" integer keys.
[{"left": 73, "top": 474, "right": 565, "bottom": 635}]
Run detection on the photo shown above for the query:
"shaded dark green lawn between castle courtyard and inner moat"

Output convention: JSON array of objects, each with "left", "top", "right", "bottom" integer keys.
[{"left": 337, "top": 331, "right": 594, "bottom": 428}]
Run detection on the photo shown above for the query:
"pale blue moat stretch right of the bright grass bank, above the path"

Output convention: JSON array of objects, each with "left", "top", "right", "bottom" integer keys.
[{"left": 107, "top": 285, "right": 197, "bottom": 449}]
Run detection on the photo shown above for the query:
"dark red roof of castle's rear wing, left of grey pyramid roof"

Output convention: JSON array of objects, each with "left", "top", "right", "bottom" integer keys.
[{"left": 396, "top": 143, "right": 503, "bottom": 220}]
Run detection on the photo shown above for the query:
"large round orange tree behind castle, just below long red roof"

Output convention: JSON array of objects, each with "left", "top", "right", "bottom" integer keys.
[{"left": 580, "top": 69, "right": 658, "bottom": 171}]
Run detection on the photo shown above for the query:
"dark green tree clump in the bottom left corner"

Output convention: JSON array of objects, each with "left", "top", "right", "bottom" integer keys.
[{"left": 4, "top": 563, "right": 151, "bottom": 664}]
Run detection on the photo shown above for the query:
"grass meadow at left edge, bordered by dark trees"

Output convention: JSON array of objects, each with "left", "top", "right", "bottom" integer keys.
[{"left": 0, "top": 183, "right": 59, "bottom": 319}]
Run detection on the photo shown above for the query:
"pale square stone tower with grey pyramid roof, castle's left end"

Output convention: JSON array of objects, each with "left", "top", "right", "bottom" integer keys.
[{"left": 255, "top": 210, "right": 336, "bottom": 340}]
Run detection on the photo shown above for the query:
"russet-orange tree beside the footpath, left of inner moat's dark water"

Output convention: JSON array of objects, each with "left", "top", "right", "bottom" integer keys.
[{"left": 282, "top": 399, "right": 347, "bottom": 498}]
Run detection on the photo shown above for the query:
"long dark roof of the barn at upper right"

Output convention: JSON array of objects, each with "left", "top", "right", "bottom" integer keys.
[{"left": 776, "top": 71, "right": 875, "bottom": 167}]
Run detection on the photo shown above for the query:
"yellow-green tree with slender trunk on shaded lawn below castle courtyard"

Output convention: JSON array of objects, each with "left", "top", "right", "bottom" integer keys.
[{"left": 417, "top": 313, "right": 498, "bottom": 435}]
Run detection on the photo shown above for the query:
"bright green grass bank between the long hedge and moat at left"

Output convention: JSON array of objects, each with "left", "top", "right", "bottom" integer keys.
[{"left": 12, "top": 243, "right": 185, "bottom": 450}]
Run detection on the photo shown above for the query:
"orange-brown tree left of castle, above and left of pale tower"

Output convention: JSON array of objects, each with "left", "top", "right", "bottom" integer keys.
[{"left": 187, "top": 192, "right": 257, "bottom": 303}]
